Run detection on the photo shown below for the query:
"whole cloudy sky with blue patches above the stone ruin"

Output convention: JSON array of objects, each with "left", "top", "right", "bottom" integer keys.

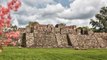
[{"left": 0, "top": 0, "right": 107, "bottom": 27}]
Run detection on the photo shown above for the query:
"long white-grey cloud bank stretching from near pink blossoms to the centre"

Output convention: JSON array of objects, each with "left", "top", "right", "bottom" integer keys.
[{"left": 13, "top": 3, "right": 64, "bottom": 25}]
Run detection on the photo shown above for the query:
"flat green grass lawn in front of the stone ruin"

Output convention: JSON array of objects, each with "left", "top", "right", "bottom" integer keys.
[{"left": 0, "top": 47, "right": 107, "bottom": 60}]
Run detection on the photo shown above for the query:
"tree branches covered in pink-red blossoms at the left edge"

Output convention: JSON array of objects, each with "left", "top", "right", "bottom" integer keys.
[{"left": 0, "top": 0, "right": 21, "bottom": 48}]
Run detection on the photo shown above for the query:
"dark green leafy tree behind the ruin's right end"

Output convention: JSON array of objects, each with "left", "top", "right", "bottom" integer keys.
[{"left": 90, "top": 7, "right": 107, "bottom": 32}]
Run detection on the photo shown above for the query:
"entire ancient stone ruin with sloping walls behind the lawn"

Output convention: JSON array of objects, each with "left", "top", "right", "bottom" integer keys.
[{"left": 19, "top": 24, "right": 107, "bottom": 49}]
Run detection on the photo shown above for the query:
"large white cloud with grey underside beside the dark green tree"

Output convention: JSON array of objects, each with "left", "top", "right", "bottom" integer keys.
[{"left": 59, "top": 0, "right": 104, "bottom": 20}]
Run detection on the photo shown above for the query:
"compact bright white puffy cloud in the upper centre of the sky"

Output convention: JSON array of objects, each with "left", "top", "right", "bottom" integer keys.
[{"left": 40, "top": 4, "right": 64, "bottom": 18}]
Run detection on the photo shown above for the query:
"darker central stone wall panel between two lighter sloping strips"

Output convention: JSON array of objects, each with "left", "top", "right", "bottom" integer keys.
[{"left": 34, "top": 33, "right": 57, "bottom": 48}]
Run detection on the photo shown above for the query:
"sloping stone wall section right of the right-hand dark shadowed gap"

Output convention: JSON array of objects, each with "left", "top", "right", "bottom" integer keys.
[{"left": 69, "top": 33, "right": 107, "bottom": 49}]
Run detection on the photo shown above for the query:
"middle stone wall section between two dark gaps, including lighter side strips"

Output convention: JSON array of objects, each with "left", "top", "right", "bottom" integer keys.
[{"left": 26, "top": 33, "right": 68, "bottom": 48}]
